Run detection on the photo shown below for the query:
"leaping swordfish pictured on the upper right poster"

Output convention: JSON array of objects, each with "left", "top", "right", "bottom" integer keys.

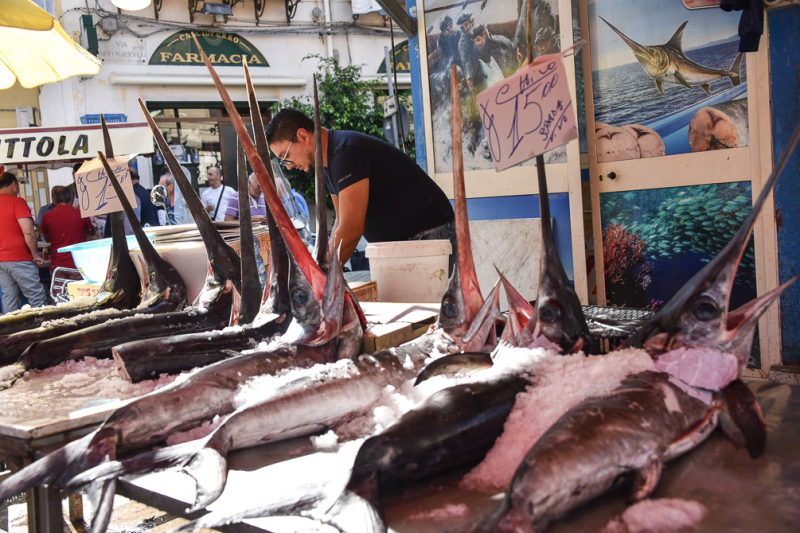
[{"left": 600, "top": 17, "right": 744, "bottom": 96}]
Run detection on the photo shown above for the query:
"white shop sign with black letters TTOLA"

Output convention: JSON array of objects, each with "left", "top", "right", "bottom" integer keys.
[{"left": 0, "top": 123, "right": 153, "bottom": 165}]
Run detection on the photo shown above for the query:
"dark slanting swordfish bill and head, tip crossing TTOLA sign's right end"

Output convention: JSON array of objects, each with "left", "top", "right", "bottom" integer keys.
[{"left": 139, "top": 98, "right": 242, "bottom": 300}]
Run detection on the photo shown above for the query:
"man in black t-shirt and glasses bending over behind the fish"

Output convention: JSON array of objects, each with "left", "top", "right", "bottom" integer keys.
[{"left": 266, "top": 109, "right": 456, "bottom": 264}]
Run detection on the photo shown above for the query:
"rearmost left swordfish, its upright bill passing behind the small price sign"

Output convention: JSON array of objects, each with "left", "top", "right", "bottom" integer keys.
[{"left": 0, "top": 118, "right": 141, "bottom": 336}]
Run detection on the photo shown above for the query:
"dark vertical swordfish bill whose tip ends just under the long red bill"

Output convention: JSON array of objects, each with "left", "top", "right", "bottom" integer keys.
[{"left": 231, "top": 137, "right": 261, "bottom": 325}]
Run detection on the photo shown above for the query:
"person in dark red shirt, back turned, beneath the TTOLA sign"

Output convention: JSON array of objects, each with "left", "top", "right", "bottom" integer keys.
[{"left": 42, "top": 187, "right": 92, "bottom": 274}]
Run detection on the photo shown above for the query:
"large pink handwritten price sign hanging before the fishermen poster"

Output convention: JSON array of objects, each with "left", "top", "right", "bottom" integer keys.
[{"left": 477, "top": 54, "right": 578, "bottom": 172}]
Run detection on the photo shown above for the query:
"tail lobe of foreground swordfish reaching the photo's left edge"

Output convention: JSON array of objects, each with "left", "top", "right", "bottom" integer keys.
[{"left": 0, "top": 434, "right": 93, "bottom": 501}]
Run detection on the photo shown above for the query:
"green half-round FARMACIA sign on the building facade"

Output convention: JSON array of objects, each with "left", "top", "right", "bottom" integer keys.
[{"left": 150, "top": 30, "right": 269, "bottom": 67}]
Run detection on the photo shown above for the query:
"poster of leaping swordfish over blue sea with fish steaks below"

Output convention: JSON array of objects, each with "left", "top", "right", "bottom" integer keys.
[{"left": 589, "top": 0, "right": 750, "bottom": 163}]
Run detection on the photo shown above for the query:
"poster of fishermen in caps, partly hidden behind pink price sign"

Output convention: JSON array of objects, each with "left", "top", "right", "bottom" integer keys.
[{"left": 424, "top": 0, "right": 566, "bottom": 173}]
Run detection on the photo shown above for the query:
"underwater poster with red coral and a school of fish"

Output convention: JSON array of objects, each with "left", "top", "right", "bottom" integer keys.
[{"left": 600, "top": 182, "right": 756, "bottom": 309}]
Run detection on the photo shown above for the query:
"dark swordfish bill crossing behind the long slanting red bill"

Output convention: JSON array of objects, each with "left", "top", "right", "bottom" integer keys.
[{"left": 245, "top": 58, "right": 292, "bottom": 323}]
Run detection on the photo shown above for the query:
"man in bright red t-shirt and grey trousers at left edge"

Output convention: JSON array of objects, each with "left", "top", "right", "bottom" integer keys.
[{"left": 0, "top": 172, "right": 47, "bottom": 313}]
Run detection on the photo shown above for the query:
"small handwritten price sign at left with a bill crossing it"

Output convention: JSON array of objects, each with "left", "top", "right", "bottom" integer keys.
[{"left": 75, "top": 156, "right": 137, "bottom": 218}]
